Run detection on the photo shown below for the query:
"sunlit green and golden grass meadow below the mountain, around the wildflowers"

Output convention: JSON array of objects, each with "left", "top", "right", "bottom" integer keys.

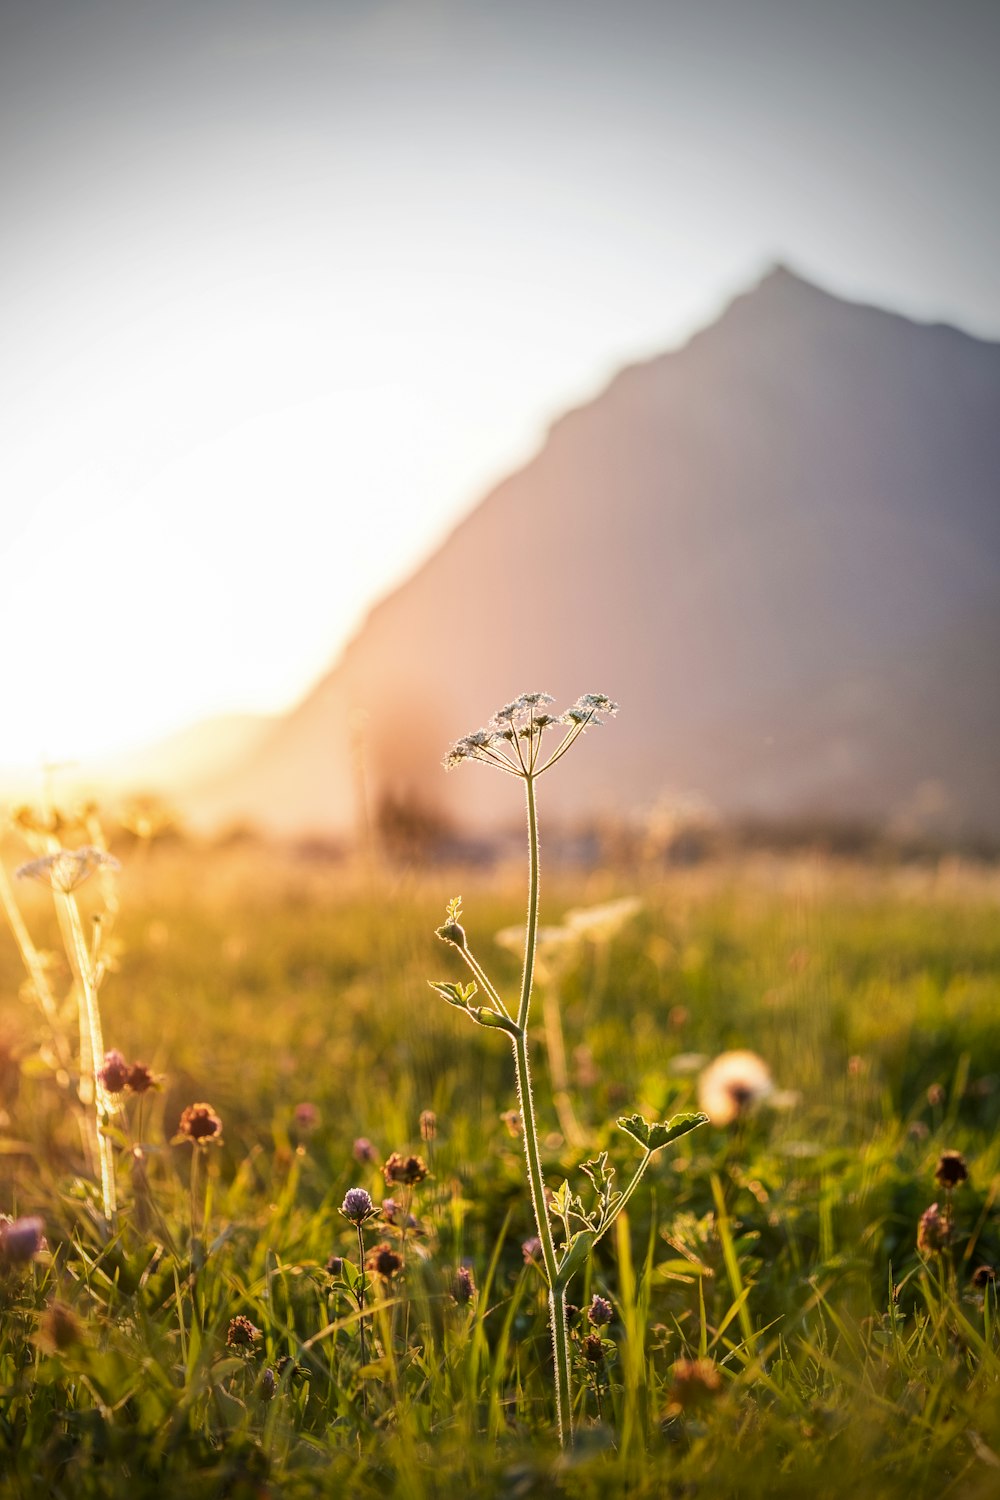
[{"left": 0, "top": 833, "right": 1000, "bottom": 1500}]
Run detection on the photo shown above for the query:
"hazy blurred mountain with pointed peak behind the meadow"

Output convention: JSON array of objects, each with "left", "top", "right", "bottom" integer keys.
[{"left": 182, "top": 267, "right": 1000, "bottom": 836}]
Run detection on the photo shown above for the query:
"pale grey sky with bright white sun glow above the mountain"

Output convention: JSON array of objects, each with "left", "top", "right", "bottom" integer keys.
[{"left": 0, "top": 0, "right": 1000, "bottom": 767}]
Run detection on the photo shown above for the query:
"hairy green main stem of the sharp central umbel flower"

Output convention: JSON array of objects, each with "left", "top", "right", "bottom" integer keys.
[{"left": 513, "top": 776, "right": 573, "bottom": 1448}]
